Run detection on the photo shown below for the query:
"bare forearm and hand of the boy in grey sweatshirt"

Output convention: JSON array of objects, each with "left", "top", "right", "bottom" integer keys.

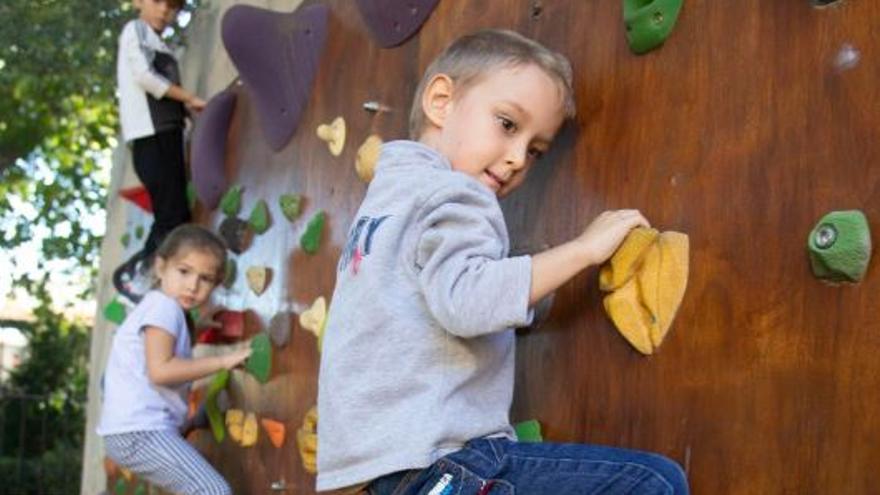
[{"left": 529, "top": 210, "right": 649, "bottom": 306}]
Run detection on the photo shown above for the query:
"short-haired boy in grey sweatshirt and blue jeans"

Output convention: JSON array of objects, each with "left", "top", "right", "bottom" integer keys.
[{"left": 317, "top": 30, "right": 688, "bottom": 495}]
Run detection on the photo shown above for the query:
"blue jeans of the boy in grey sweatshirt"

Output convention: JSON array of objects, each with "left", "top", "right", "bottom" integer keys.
[{"left": 367, "top": 438, "right": 688, "bottom": 495}]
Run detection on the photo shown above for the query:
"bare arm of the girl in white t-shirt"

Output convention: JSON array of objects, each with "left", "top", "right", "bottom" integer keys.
[{"left": 144, "top": 326, "right": 251, "bottom": 385}]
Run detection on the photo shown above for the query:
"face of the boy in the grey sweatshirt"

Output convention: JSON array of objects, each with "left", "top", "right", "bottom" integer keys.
[{"left": 423, "top": 64, "right": 564, "bottom": 197}]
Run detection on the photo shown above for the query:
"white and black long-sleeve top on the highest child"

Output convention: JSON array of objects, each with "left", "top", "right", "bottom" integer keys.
[{"left": 116, "top": 19, "right": 184, "bottom": 142}]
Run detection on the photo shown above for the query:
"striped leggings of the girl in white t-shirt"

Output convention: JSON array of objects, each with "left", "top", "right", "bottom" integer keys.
[{"left": 104, "top": 431, "right": 232, "bottom": 495}]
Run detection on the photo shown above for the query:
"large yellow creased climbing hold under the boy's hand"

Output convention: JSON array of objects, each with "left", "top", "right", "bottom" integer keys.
[{"left": 599, "top": 228, "right": 689, "bottom": 354}]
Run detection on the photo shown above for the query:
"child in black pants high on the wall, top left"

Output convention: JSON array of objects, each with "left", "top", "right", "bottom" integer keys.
[{"left": 113, "top": 0, "right": 205, "bottom": 302}]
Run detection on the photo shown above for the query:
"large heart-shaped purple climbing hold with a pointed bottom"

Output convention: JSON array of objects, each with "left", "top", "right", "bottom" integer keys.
[{"left": 222, "top": 4, "right": 329, "bottom": 151}]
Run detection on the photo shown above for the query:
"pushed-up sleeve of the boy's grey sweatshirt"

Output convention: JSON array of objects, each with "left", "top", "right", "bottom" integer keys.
[{"left": 415, "top": 180, "right": 532, "bottom": 337}]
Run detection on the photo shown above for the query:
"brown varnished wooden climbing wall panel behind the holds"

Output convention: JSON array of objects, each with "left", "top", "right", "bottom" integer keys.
[{"left": 184, "top": 0, "right": 880, "bottom": 494}]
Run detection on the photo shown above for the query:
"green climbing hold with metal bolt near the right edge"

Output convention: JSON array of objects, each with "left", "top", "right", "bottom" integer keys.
[{"left": 807, "top": 210, "right": 871, "bottom": 283}]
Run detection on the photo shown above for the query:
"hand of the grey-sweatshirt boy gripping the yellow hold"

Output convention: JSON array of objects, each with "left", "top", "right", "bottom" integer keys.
[{"left": 575, "top": 210, "right": 651, "bottom": 265}]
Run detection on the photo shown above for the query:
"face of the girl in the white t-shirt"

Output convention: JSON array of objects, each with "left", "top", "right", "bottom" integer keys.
[{"left": 155, "top": 248, "right": 220, "bottom": 311}]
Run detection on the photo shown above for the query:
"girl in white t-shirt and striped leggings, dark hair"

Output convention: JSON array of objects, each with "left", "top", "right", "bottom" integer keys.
[{"left": 97, "top": 224, "right": 251, "bottom": 495}]
